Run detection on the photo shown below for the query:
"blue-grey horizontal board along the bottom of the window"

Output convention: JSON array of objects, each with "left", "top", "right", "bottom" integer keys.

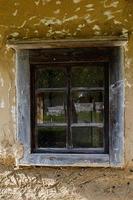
[{"left": 18, "top": 153, "right": 110, "bottom": 167}]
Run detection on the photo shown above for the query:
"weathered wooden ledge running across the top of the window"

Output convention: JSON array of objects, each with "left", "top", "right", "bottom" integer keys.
[{"left": 7, "top": 37, "right": 128, "bottom": 49}]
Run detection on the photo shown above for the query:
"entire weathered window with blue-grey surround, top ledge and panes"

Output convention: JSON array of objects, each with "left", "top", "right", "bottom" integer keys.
[{"left": 11, "top": 40, "right": 124, "bottom": 167}]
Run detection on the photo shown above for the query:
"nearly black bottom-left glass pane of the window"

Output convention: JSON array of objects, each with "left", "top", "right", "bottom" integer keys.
[{"left": 37, "top": 127, "right": 66, "bottom": 148}]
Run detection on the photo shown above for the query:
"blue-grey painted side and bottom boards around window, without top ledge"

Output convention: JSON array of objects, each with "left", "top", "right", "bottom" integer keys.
[{"left": 16, "top": 47, "right": 124, "bottom": 167}]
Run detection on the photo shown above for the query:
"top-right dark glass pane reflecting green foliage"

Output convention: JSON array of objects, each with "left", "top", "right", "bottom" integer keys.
[{"left": 72, "top": 66, "right": 104, "bottom": 87}]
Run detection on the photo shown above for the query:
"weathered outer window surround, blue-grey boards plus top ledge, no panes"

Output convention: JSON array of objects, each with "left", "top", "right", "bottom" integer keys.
[{"left": 9, "top": 38, "right": 126, "bottom": 167}]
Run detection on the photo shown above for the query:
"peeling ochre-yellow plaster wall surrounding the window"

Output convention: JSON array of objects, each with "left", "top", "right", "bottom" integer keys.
[{"left": 0, "top": 0, "right": 133, "bottom": 200}]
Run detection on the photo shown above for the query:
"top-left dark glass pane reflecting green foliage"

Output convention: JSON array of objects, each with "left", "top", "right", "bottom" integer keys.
[{"left": 36, "top": 69, "right": 65, "bottom": 88}]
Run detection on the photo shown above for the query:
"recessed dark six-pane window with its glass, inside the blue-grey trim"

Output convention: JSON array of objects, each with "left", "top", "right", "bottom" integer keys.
[{"left": 31, "top": 49, "right": 109, "bottom": 153}]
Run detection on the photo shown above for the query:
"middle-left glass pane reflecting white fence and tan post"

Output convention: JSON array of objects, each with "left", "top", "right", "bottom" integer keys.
[{"left": 36, "top": 92, "right": 67, "bottom": 124}]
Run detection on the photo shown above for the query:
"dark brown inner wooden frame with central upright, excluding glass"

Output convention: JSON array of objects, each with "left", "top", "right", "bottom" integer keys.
[{"left": 30, "top": 48, "right": 109, "bottom": 154}]
